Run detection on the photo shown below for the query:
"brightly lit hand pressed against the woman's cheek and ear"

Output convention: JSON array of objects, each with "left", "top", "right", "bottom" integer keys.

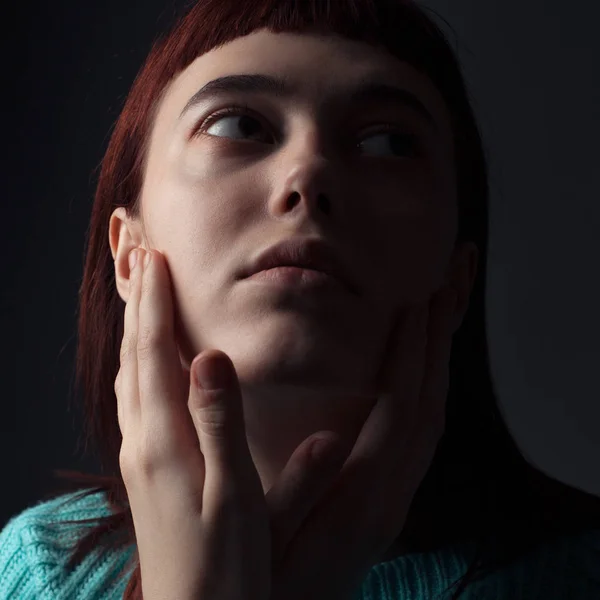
[{"left": 115, "top": 248, "right": 350, "bottom": 600}]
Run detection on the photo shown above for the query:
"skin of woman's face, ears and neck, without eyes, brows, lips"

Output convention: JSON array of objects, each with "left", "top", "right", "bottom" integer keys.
[{"left": 109, "top": 30, "right": 478, "bottom": 548}]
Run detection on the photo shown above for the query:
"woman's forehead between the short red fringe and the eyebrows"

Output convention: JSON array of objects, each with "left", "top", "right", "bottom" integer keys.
[{"left": 159, "top": 29, "right": 451, "bottom": 141}]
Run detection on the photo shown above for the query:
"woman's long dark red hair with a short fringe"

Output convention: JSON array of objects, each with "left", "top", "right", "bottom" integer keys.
[{"left": 39, "top": 0, "right": 600, "bottom": 600}]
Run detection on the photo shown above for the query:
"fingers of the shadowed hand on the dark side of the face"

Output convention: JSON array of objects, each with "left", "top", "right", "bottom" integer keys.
[{"left": 330, "top": 292, "right": 455, "bottom": 502}]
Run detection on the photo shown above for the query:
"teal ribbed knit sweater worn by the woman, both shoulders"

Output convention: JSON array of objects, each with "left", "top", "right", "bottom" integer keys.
[{"left": 0, "top": 494, "right": 600, "bottom": 600}]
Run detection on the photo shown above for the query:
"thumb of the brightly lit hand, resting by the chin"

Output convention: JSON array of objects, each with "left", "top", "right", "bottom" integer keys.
[{"left": 188, "top": 350, "right": 253, "bottom": 502}]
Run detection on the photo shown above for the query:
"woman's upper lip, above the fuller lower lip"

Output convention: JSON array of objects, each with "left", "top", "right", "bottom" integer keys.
[{"left": 241, "top": 238, "right": 358, "bottom": 293}]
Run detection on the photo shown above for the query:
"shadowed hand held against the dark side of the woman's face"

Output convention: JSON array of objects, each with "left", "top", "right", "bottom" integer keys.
[{"left": 270, "top": 289, "right": 456, "bottom": 600}]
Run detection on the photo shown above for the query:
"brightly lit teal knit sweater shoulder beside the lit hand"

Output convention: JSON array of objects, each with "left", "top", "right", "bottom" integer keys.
[{"left": 0, "top": 492, "right": 133, "bottom": 600}]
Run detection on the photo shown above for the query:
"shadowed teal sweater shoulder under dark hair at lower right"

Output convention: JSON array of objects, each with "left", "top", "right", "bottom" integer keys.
[{"left": 359, "top": 529, "right": 600, "bottom": 600}]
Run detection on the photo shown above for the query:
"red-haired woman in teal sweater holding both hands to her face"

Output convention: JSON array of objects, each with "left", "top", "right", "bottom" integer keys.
[{"left": 3, "top": 0, "right": 600, "bottom": 600}]
